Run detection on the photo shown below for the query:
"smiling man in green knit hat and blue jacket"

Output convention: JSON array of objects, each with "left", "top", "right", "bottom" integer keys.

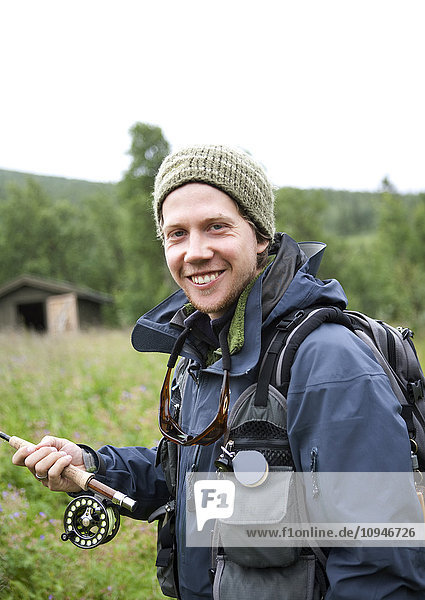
[{"left": 13, "top": 146, "right": 425, "bottom": 600}]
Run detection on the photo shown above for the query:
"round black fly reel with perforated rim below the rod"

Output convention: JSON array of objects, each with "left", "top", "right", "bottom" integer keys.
[{"left": 61, "top": 496, "right": 120, "bottom": 550}]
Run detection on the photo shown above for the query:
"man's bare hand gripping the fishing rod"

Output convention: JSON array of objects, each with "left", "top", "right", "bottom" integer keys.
[{"left": 12, "top": 435, "right": 85, "bottom": 492}]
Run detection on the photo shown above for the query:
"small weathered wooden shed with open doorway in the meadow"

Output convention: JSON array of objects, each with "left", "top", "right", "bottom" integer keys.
[{"left": 0, "top": 275, "right": 112, "bottom": 333}]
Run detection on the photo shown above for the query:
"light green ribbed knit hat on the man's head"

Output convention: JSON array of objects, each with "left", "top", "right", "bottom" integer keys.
[{"left": 153, "top": 146, "right": 275, "bottom": 239}]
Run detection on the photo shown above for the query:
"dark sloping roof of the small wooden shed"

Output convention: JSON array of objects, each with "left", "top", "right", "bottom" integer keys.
[{"left": 0, "top": 275, "right": 113, "bottom": 304}]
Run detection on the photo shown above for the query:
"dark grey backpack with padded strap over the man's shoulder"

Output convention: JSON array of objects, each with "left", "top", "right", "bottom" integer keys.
[{"left": 264, "top": 306, "right": 425, "bottom": 471}]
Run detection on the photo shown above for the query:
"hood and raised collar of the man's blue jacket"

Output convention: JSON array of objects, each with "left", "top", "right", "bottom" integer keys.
[{"left": 131, "top": 234, "right": 347, "bottom": 376}]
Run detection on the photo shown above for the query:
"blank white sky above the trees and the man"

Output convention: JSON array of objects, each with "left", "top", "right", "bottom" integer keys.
[{"left": 0, "top": 0, "right": 425, "bottom": 191}]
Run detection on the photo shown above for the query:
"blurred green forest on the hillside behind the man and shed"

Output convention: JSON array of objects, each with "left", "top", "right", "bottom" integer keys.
[{"left": 0, "top": 122, "right": 425, "bottom": 333}]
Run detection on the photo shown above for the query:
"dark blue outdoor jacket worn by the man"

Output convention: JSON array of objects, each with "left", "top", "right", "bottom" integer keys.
[{"left": 99, "top": 236, "right": 425, "bottom": 600}]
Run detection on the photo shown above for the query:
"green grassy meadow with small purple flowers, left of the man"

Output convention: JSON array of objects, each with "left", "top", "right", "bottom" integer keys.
[{"left": 0, "top": 331, "right": 169, "bottom": 600}]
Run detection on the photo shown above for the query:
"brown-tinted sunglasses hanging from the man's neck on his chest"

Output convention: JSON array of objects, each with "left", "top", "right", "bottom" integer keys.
[{"left": 159, "top": 366, "right": 230, "bottom": 446}]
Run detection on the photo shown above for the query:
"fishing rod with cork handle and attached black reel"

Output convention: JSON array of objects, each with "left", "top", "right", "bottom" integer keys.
[{"left": 0, "top": 431, "right": 137, "bottom": 549}]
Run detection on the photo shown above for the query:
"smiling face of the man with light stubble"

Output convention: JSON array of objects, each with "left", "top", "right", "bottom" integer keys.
[{"left": 162, "top": 183, "right": 267, "bottom": 319}]
